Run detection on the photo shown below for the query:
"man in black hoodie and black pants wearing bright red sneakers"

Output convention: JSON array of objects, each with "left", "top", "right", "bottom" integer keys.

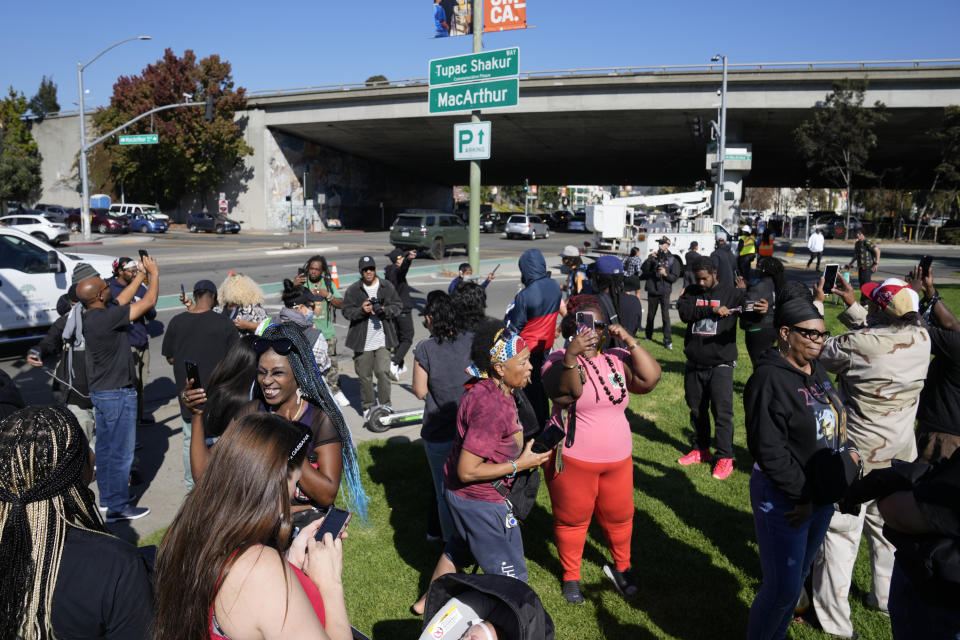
[{"left": 677, "top": 258, "right": 767, "bottom": 480}]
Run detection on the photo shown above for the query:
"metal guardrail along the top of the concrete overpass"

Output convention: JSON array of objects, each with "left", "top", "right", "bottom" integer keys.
[{"left": 247, "top": 58, "right": 960, "bottom": 97}]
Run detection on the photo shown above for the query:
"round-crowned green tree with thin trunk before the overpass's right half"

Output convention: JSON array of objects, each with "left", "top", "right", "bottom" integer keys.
[{"left": 794, "top": 80, "right": 887, "bottom": 239}]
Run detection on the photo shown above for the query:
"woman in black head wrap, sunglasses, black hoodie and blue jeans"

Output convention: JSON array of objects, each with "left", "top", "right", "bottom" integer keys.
[{"left": 743, "top": 282, "right": 860, "bottom": 640}]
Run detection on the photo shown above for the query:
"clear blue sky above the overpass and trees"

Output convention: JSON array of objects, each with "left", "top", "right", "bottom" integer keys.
[{"left": 0, "top": 0, "right": 960, "bottom": 110}]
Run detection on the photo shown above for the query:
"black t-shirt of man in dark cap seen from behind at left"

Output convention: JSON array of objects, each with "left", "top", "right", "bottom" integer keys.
[{"left": 161, "top": 310, "right": 240, "bottom": 420}]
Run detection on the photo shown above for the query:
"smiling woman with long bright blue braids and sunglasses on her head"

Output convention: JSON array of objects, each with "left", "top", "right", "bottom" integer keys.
[{"left": 184, "top": 323, "right": 368, "bottom": 528}]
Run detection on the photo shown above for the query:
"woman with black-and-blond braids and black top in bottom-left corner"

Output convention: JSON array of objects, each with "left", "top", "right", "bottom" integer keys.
[{"left": 0, "top": 407, "right": 153, "bottom": 640}]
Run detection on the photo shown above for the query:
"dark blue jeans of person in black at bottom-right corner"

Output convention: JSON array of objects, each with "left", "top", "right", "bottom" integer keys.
[{"left": 889, "top": 563, "right": 960, "bottom": 640}]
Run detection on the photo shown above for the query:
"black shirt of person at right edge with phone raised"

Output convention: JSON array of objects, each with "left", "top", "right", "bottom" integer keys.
[{"left": 917, "top": 327, "right": 960, "bottom": 436}]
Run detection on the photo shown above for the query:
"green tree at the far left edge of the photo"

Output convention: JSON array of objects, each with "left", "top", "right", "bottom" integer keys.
[{"left": 0, "top": 87, "right": 41, "bottom": 214}]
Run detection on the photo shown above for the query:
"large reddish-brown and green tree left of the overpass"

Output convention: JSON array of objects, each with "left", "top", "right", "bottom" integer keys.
[{"left": 92, "top": 49, "right": 253, "bottom": 208}]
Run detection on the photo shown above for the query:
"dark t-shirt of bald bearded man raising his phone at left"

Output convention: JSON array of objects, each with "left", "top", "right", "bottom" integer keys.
[{"left": 83, "top": 305, "right": 136, "bottom": 391}]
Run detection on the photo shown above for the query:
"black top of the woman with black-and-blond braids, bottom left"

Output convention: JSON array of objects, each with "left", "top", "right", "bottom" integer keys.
[{"left": 51, "top": 528, "right": 153, "bottom": 640}]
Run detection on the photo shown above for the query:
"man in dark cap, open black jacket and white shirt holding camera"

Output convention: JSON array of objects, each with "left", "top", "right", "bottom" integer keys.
[{"left": 343, "top": 256, "right": 403, "bottom": 419}]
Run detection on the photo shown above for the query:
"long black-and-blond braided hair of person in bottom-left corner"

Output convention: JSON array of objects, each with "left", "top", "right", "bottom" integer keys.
[{"left": 0, "top": 407, "right": 109, "bottom": 640}]
